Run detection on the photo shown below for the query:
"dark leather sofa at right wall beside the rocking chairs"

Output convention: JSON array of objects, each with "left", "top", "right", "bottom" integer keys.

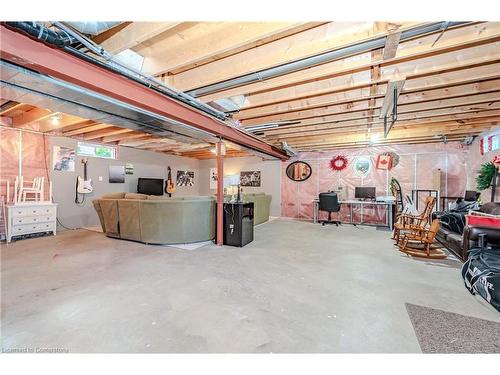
[{"left": 433, "top": 202, "right": 500, "bottom": 261}]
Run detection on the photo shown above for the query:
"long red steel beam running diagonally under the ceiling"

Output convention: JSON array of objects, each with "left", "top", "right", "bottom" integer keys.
[{"left": 0, "top": 25, "right": 288, "bottom": 160}]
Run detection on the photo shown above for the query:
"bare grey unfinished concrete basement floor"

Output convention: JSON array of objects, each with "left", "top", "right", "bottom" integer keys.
[{"left": 2, "top": 220, "right": 499, "bottom": 352}]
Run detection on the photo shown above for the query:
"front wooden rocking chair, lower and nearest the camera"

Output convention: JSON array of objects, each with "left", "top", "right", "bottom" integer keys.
[{"left": 399, "top": 219, "right": 446, "bottom": 259}]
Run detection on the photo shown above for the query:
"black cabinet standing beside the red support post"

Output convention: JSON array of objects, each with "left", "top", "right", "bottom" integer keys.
[{"left": 224, "top": 203, "right": 253, "bottom": 247}]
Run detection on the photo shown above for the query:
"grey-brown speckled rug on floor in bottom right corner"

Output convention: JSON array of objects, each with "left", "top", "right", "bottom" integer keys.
[{"left": 405, "top": 303, "right": 500, "bottom": 353}]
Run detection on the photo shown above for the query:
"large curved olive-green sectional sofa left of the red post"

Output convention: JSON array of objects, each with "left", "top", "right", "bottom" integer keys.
[{"left": 92, "top": 193, "right": 216, "bottom": 244}]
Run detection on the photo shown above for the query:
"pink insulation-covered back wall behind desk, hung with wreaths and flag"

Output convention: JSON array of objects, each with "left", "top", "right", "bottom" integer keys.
[{"left": 281, "top": 142, "right": 468, "bottom": 223}]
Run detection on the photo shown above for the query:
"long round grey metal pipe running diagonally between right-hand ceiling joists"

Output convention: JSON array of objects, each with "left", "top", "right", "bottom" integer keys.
[{"left": 186, "top": 21, "right": 469, "bottom": 98}]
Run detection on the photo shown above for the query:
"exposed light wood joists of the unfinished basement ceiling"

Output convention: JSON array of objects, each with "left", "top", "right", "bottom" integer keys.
[{"left": 0, "top": 22, "right": 500, "bottom": 159}]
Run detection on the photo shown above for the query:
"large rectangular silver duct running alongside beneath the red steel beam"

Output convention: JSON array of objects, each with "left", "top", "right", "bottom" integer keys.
[{"left": 0, "top": 61, "right": 218, "bottom": 143}]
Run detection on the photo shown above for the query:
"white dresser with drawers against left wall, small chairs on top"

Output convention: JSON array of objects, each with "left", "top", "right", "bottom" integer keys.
[{"left": 7, "top": 201, "right": 57, "bottom": 242}]
